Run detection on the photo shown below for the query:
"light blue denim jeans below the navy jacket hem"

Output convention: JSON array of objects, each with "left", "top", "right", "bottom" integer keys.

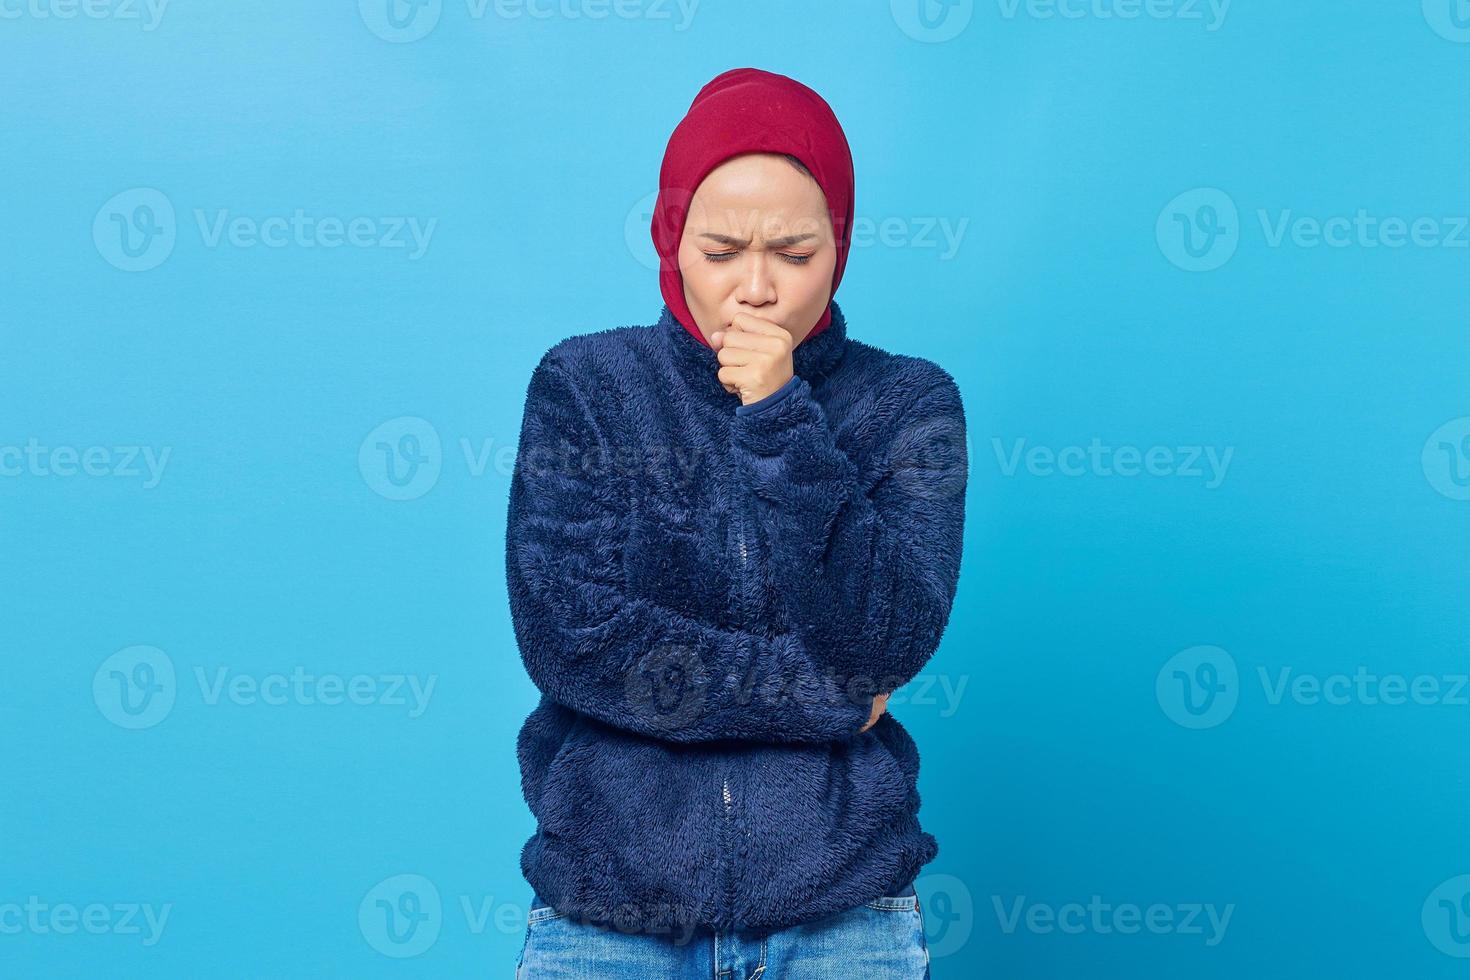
[{"left": 516, "top": 884, "right": 929, "bottom": 980}]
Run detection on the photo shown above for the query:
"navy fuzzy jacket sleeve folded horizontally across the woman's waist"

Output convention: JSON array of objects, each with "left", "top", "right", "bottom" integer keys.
[{"left": 506, "top": 348, "right": 875, "bottom": 742}]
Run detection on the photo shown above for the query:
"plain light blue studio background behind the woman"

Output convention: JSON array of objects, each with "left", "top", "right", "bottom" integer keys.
[{"left": 0, "top": 0, "right": 1470, "bottom": 979}]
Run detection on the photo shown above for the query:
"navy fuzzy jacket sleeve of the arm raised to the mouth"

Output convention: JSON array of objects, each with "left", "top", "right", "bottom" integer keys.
[{"left": 735, "top": 364, "right": 969, "bottom": 691}]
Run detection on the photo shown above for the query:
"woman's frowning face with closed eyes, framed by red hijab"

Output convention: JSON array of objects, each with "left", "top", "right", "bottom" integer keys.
[{"left": 679, "top": 153, "right": 836, "bottom": 345}]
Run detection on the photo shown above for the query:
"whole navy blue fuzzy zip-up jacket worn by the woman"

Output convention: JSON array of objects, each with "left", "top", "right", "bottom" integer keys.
[{"left": 506, "top": 303, "right": 969, "bottom": 932}]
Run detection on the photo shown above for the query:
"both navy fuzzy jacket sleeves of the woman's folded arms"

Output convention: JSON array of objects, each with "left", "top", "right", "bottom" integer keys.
[{"left": 506, "top": 351, "right": 966, "bottom": 742}]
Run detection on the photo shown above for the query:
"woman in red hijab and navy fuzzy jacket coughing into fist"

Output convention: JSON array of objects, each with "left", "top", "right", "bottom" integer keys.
[{"left": 506, "top": 68, "right": 967, "bottom": 980}]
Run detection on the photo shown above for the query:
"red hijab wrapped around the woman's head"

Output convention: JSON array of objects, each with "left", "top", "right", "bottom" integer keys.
[{"left": 653, "top": 68, "right": 853, "bottom": 347}]
